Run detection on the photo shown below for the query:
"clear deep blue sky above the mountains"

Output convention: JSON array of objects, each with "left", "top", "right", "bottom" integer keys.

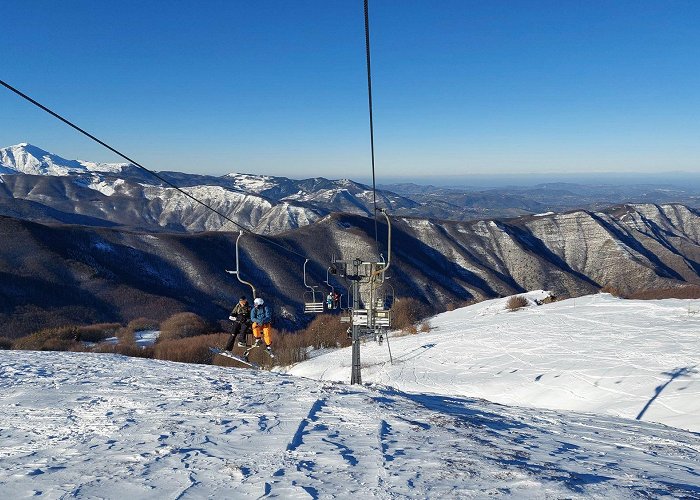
[{"left": 0, "top": 0, "right": 700, "bottom": 181}]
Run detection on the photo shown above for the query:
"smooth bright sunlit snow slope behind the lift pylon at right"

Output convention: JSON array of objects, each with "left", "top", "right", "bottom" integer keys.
[{"left": 290, "top": 291, "right": 700, "bottom": 432}]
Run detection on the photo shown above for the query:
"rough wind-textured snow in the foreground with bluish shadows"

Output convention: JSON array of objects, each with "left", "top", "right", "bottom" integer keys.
[{"left": 0, "top": 351, "right": 700, "bottom": 499}]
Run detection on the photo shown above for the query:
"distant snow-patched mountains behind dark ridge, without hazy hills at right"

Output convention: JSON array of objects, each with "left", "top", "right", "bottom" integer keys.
[{"left": 0, "top": 144, "right": 418, "bottom": 234}]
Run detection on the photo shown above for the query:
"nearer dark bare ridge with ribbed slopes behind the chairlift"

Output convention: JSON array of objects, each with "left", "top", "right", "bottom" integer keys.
[{"left": 0, "top": 205, "right": 700, "bottom": 336}]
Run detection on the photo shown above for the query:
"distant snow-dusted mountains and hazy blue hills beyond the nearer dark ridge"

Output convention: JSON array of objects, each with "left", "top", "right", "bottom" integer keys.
[{"left": 5, "top": 143, "right": 700, "bottom": 234}]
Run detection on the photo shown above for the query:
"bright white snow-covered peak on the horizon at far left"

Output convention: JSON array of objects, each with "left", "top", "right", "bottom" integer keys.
[{"left": 0, "top": 143, "right": 127, "bottom": 175}]
